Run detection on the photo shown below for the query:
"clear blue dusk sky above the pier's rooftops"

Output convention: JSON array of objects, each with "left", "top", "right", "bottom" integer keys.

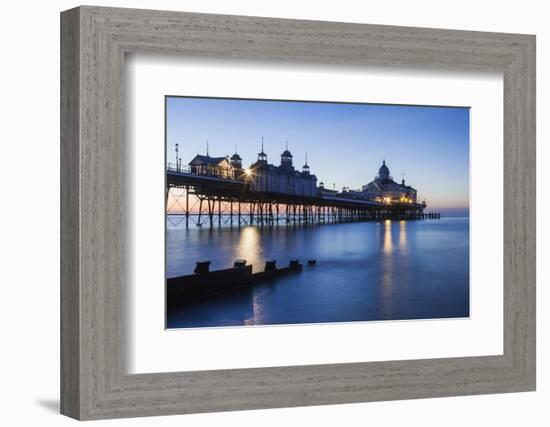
[{"left": 166, "top": 97, "right": 469, "bottom": 215}]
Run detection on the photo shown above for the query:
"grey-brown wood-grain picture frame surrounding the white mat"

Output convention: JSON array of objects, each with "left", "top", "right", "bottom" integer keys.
[{"left": 61, "top": 6, "right": 536, "bottom": 420}]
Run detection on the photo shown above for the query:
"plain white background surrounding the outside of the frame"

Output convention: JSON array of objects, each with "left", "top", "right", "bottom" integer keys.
[{"left": 0, "top": 0, "right": 550, "bottom": 427}]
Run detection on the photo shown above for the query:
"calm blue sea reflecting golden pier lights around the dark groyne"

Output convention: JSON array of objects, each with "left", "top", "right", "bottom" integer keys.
[{"left": 167, "top": 218, "right": 469, "bottom": 328}]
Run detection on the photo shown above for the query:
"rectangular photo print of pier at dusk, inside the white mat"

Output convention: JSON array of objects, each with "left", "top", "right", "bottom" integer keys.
[{"left": 165, "top": 95, "right": 470, "bottom": 329}]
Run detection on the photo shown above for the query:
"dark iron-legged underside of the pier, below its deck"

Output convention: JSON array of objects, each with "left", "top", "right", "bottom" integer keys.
[{"left": 166, "top": 170, "right": 439, "bottom": 227}]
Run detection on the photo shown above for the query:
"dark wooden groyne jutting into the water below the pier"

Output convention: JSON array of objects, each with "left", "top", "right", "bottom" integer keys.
[{"left": 166, "top": 260, "right": 306, "bottom": 308}]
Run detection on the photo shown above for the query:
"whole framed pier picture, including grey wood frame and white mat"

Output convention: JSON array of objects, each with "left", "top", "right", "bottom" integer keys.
[{"left": 61, "top": 6, "right": 535, "bottom": 419}]
